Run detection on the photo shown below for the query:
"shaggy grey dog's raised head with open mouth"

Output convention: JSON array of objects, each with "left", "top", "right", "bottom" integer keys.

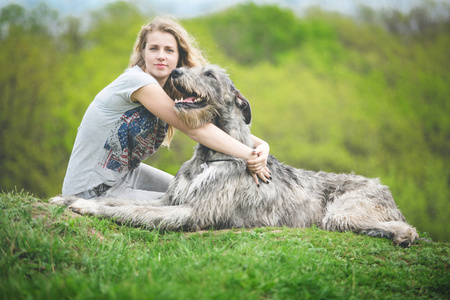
[{"left": 171, "top": 65, "right": 252, "bottom": 128}]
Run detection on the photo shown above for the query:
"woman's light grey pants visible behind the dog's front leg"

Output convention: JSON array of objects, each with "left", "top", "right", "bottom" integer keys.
[{"left": 103, "top": 163, "right": 173, "bottom": 200}]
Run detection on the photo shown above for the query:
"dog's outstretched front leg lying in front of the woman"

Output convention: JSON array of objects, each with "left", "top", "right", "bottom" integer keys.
[{"left": 69, "top": 199, "right": 195, "bottom": 230}]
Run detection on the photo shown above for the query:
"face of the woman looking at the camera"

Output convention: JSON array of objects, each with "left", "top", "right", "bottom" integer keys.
[{"left": 142, "top": 31, "right": 179, "bottom": 86}]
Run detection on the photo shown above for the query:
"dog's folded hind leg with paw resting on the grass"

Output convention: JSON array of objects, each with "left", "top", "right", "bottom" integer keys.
[{"left": 320, "top": 193, "right": 419, "bottom": 247}]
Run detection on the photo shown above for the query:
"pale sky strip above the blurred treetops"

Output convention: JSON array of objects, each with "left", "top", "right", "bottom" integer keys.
[{"left": 0, "top": 0, "right": 434, "bottom": 18}]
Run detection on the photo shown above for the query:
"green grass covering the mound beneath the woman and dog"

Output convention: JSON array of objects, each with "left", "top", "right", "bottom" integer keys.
[{"left": 0, "top": 192, "right": 450, "bottom": 300}]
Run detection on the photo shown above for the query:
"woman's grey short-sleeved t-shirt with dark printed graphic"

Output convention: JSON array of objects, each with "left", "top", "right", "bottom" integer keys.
[{"left": 62, "top": 66, "right": 168, "bottom": 195}]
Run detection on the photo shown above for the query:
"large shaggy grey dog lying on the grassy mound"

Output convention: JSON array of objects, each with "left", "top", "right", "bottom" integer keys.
[{"left": 52, "top": 65, "right": 419, "bottom": 246}]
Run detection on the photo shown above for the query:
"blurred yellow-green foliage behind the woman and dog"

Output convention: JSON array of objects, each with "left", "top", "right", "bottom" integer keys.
[{"left": 0, "top": 1, "right": 450, "bottom": 240}]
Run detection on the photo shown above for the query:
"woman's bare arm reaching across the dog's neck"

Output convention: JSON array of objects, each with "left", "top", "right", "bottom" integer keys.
[{"left": 131, "top": 84, "right": 267, "bottom": 183}]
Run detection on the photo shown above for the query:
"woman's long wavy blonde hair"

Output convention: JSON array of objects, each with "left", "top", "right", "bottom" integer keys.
[{"left": 128, "top": 17, "right": 207, "bottom": 147}]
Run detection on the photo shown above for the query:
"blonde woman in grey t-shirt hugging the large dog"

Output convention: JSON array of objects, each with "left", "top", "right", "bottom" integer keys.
[{"left": 63, "top": 18, "right": 270, "bottom": 199}]
